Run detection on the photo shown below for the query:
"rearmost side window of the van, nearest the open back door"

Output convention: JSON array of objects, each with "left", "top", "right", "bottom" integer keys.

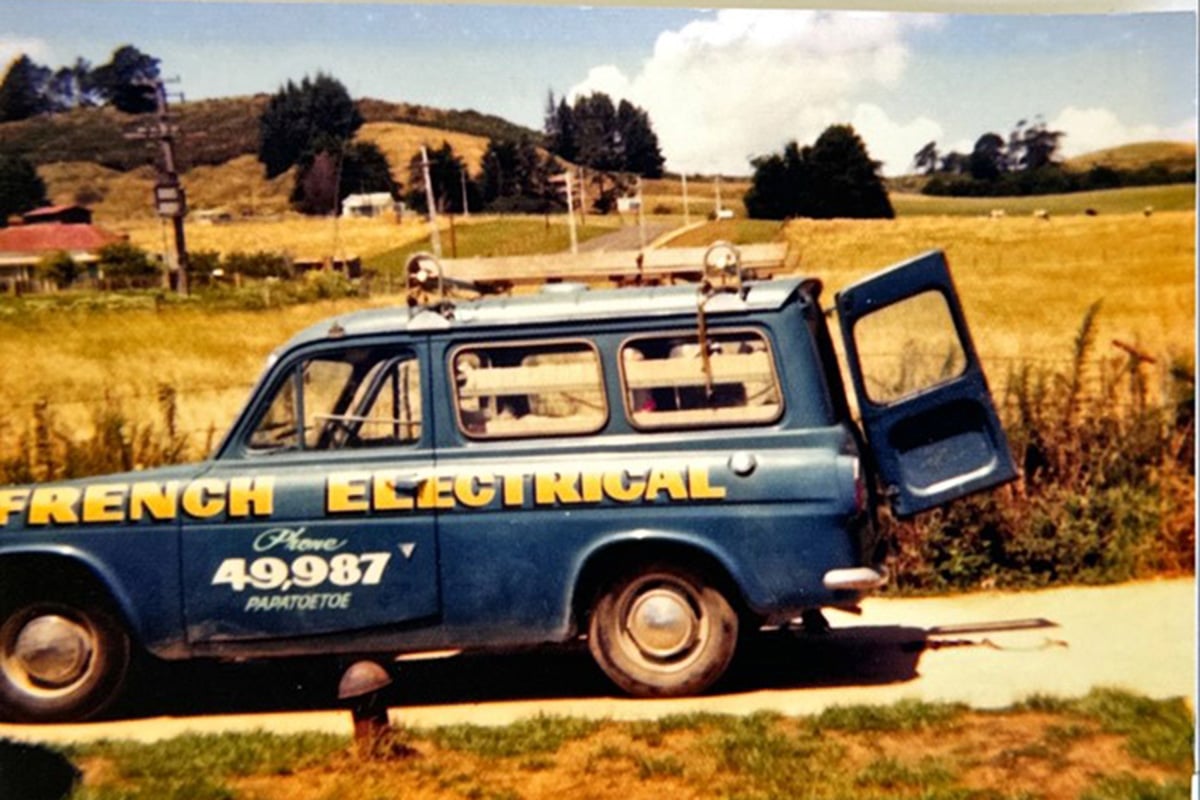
[{"left": 620, "top": 331, "right": 784, "bottom": 428}]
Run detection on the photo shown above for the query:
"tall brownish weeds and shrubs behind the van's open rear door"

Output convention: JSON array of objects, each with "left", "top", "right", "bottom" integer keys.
[{"left": 884, "top": 306, "right": 1195, "bottom": 591}]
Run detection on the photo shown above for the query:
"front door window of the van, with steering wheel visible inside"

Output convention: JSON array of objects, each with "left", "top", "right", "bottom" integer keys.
[{"left": 248, "top": 348, "right": 421, "bottom": 452}]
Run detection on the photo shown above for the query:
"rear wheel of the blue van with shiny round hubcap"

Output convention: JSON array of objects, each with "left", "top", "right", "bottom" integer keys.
[{"left": 588, "top": 564, "right": 738, "bottom": 697}]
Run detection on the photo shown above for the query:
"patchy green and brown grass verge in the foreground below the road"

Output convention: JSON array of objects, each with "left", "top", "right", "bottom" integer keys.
[{"left": 30, "top": 690, "right": 1192, "bottom": 800}]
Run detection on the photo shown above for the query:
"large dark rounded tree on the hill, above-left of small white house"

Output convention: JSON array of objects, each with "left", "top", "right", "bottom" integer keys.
[{"left": 258, "top": 72, "right": 362, "bottom": 178}]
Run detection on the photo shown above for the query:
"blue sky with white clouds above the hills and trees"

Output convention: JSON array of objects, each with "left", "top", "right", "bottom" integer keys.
[{"left": 0, "top": 0, "right": 1196, "bottom": 175}]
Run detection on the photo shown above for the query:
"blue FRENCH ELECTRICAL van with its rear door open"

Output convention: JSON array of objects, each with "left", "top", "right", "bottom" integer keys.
[{"left": 0, "top": 248, "right": 1015, "bottom": 721}]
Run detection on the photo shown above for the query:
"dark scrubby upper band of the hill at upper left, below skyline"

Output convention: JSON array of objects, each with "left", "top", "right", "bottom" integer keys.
[{"left": 0, "top": 95, "right": 540, "bottom": 172}]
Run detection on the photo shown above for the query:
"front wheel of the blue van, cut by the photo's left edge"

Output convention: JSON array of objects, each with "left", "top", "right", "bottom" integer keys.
[{"left": 0, "top": 594, "right": 131, "bottom": 722}]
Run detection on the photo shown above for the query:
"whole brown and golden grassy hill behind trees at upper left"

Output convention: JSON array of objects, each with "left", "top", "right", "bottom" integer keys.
[{"left": 0, "top": 95, "right": 525, "bottom": 222}]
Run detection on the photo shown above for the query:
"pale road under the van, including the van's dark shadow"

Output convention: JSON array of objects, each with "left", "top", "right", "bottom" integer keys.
[{"left": 0, "top": 578, "right": 1196, "bottom": 742}]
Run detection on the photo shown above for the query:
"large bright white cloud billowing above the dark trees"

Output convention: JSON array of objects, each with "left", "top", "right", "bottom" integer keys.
[{"left": 568, "top": 8, "right": 941, "bottom": 173}]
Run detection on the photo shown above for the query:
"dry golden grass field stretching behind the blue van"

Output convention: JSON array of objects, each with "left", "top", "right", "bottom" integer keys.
[{"left": 0, "top": 211, "right": 1195, "bottom": 455}]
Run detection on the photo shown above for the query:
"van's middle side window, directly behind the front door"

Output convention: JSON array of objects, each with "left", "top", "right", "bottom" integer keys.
[{"left": 450, "top": 342, "right": 608, "bottom": 439}]
